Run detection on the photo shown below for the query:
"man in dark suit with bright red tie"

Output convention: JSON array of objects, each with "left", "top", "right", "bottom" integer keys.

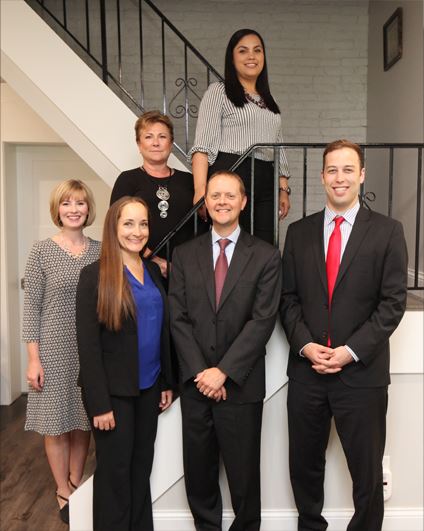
[{"left": 280, "top": 140, "right": 407, "bottom": 531}]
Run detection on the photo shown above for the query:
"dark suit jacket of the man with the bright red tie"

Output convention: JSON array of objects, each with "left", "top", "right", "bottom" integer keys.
[{"left": 280, "top": 207, "right": 408, "bottom": 387}]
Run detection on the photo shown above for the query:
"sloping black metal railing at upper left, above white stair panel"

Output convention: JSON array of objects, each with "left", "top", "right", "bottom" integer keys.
[{"left": 26, "top": 0, "right": 222, "bottom": 157}]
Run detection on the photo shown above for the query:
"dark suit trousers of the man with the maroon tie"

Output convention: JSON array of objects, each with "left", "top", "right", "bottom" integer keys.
[{"left": 181, "top": 394, "right": 263, "bottom": 531}]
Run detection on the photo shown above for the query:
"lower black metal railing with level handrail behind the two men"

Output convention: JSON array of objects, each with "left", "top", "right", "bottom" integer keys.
[{"left": 153, "top": 143, "right": 424, "bottom": 290}]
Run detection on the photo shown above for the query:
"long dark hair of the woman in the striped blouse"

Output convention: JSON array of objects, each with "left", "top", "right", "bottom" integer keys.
[{"left": 224, "top": 28, "right": 280, "bottom": 114}]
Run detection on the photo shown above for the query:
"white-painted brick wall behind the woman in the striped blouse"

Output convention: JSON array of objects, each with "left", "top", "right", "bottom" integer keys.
[{"left": 38, "top": 0, "right": 368, "bottom": 222}]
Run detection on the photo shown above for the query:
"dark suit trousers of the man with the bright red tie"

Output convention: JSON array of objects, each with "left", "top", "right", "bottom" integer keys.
[{"left": 287, "top": 375, "right": 387, "bottom": 531}]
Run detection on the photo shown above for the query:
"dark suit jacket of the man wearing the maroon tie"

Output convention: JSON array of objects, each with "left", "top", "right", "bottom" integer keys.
[{"left": 169, "top": 230, "right": 281, "bottom": 403}]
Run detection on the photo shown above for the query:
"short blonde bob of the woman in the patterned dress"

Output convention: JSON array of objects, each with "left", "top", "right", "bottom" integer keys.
[{"left": 50, "top": 179, "right": 96, "bottom": 227}]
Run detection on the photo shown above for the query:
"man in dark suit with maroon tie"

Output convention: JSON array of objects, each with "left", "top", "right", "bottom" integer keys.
[{"left": 169, "top": 171, "right": 281, "bottom": 531}]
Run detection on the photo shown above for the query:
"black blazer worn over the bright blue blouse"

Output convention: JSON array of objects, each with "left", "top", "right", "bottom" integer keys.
[{"left": 76, "top": 261, "right": 174, "bottom": 417}]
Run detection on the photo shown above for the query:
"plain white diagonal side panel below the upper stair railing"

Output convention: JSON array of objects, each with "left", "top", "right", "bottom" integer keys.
[{"left": 0, "top": 0, "right": 186, "bottom": 186}]
